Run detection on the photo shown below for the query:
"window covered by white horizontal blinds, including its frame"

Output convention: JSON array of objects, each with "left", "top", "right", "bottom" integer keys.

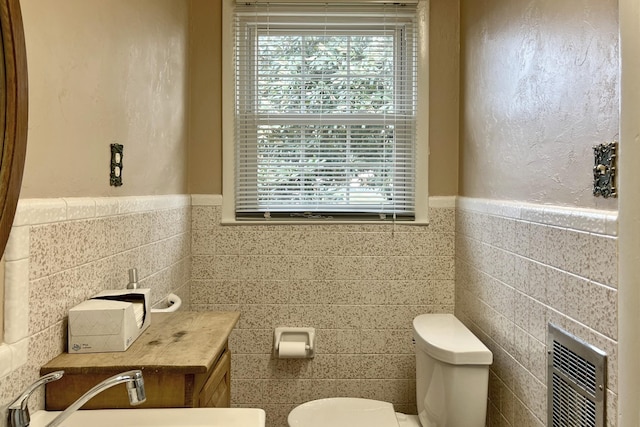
[{"left": 223, "top": 1, "right": 427, "bottom": 221}]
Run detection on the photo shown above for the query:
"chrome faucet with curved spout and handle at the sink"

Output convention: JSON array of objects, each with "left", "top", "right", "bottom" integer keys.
[{"left": 7, "top": 369, "right": 147, "bottom": 427}]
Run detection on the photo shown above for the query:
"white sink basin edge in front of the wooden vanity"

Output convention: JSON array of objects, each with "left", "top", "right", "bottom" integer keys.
[{"left": 30, "top": 408, "right": 265, "bottom": 427}]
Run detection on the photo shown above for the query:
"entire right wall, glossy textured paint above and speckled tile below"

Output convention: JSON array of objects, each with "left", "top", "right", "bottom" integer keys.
[{"left": 455, "top": 0, "right": 622, "bottom": 427}]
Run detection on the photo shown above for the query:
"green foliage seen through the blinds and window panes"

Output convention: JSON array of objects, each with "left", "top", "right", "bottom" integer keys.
[{"left": 255, "top": 34, "right": 398, "bottom": 207}]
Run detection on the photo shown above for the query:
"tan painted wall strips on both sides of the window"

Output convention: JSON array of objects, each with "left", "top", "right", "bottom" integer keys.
[{"left": 189, "top": 0, "right": 459, "bottom": 196}]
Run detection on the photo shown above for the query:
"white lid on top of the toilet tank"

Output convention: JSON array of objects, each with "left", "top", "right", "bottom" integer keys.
[{"left": 413, "top": 314, "right": 493, "bottom": 365}]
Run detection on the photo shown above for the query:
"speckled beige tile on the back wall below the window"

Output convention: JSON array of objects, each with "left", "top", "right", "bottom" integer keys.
[{"left": 192, "top": 196, "right": 455, "bottom": 427}]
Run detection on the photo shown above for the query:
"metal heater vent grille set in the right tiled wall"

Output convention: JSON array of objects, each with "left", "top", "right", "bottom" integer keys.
[{"left": 547, "top": 323, "right": 606, "bottom": 427}]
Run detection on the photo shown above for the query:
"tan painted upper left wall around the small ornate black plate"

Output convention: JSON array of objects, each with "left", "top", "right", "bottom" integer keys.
[{"left": 21, "top": 0, "right": 189, "bottom": 198}]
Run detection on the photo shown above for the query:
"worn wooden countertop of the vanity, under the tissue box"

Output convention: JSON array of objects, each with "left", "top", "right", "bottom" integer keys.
[{"left": 40, "top": 311, "right": 240, "bottom": 374}]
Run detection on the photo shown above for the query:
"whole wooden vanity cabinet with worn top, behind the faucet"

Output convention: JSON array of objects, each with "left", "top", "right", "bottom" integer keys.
[{"left": 40, "top": 311, "right": 240, "bottom": 411}]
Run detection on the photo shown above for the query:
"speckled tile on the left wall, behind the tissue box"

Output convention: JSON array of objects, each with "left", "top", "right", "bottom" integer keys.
[{"left": 0, "top": 195, "right": 191, "bottom": 425}]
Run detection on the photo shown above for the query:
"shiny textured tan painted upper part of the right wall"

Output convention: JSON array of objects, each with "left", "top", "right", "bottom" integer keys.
[{"left": 460, "top": 0, "right": 619, "bottom": 209}]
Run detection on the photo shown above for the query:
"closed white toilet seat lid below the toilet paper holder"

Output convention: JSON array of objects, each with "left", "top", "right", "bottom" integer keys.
[{"left": 287, "top": 397, "right": 399, "bottom": 427}]
